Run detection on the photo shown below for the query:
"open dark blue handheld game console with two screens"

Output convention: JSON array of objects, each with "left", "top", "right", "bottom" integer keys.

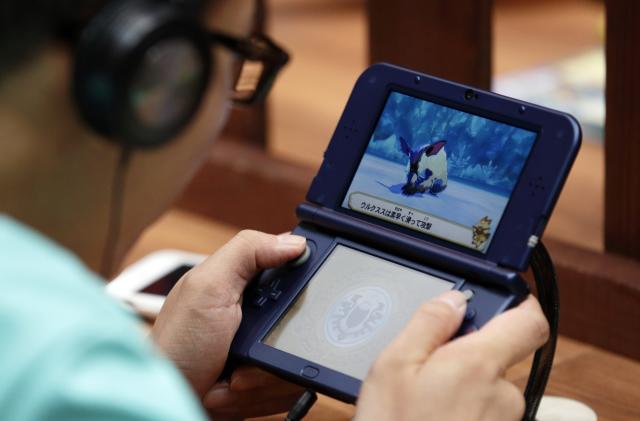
[{"left": 231, "top": 64, "right": 581, "bottom": 402}]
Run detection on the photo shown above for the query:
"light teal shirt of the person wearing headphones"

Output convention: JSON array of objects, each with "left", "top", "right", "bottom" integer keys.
[{"left": 0, "top": 214, "right": 205, "bottom": 421}]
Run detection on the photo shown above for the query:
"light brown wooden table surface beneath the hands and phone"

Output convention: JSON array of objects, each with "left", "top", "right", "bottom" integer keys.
[{"left": 126, "top": 211, "right": 640, "bottom": 421}]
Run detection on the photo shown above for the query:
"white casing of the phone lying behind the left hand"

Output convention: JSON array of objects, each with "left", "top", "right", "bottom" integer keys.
[{"left": 107, "top": 250, "right": 206, "bottom": 318}]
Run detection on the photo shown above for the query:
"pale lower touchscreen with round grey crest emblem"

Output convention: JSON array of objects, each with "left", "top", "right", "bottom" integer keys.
[{"left": 263, "top": 245, "right": 455, "bottom": 380}]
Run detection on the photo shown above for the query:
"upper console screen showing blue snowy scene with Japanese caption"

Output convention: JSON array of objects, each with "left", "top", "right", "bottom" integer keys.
[{"left": 342, "top": 92, "right": 537, "bottom": 253}]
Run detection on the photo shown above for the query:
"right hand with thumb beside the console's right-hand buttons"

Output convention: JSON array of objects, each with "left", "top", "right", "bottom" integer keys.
[{"left": 355, "top": 291, "right": 549, "bottom": 421}]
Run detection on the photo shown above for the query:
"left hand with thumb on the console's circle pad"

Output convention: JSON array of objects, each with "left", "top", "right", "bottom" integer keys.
[{"left": 151, "top": 231, "right": 306, "bottom": 397}]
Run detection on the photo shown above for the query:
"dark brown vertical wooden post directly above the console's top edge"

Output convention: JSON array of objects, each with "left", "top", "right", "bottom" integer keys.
[{"left": 367, "top": 0, "right": 493, "bottom": 89}]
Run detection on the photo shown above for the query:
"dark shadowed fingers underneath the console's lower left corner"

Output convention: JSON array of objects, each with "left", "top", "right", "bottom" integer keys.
[{"left": 202, "top": 366, "right": 304, "bottom": 421}]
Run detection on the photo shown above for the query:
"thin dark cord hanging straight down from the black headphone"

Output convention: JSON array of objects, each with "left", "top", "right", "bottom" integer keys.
[{"left": 100, "top": 146, "right": 132, "bottom": 277}]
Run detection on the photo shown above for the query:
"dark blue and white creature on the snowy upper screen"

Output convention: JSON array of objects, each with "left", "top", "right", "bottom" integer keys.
[{"left": 400, "top": 136, "right": 447, "bottom": 196}]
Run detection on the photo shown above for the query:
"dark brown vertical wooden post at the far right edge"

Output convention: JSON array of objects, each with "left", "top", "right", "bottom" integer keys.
[{"left": 604, "top": 0, "right": 640, "bottom": 260}]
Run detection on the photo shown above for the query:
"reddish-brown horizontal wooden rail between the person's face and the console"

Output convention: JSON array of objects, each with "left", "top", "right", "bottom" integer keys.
[{"left": 178, "top": 140, "right": 316, "bottom": 232}]
